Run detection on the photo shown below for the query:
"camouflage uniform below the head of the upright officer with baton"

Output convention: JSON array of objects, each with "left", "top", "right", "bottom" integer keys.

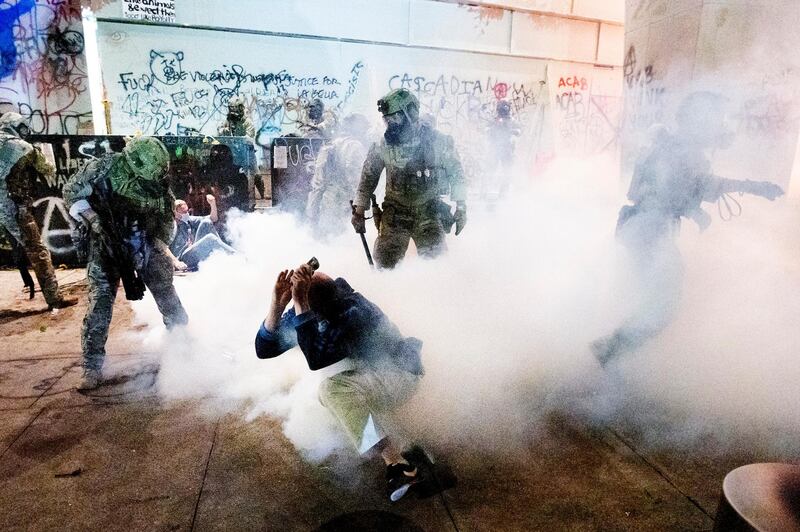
[{"left": 355, "top": 124, "right": 466, "bottom": 268}]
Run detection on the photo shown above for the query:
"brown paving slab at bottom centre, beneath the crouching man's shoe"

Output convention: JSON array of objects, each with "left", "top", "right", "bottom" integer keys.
[{"left": 196, "top": 416, "right": 453, "bottom": 530}]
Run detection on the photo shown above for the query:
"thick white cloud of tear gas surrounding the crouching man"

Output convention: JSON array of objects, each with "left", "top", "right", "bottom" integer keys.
[{"left": 123, "top": 148, "right": 800, "bottom": 459}]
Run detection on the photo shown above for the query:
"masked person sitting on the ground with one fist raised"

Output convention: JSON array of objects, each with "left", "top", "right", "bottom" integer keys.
[{"left": 169, "top": 194, "right": 236, "bottom": 270}]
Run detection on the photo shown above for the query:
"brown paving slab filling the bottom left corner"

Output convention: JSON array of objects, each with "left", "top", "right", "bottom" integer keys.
[{"left": 0, "top": 402, "right": 214, "bottom": 530}]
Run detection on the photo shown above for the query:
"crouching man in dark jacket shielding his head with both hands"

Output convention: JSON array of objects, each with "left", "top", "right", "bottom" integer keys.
[{"left": 255, "top": 264, "right": 423, "bottom": 501}]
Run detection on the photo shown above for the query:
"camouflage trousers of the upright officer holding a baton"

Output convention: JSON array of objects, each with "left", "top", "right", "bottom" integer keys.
[{"left": 375, "top": 201, "right": 447, "bottom": 268}]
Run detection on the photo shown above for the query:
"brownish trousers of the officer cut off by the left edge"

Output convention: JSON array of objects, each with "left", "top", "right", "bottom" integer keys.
[{"left": 0, "top": 204, "right": 61, "bottom": 305}]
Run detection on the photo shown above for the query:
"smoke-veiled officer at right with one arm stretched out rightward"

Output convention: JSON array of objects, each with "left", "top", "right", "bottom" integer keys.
[{"left": 591, "top": 92, "right": 783, "bottom": 365}]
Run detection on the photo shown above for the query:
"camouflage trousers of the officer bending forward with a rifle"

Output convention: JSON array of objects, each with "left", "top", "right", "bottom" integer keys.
[{"left": 81, "top": 239, "right": 189, "bottom": 371}]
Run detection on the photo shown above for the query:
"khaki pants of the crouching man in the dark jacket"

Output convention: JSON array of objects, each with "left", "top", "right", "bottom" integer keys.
[{"left": 319, "top": 367, "right": 421, "bottom": 454}]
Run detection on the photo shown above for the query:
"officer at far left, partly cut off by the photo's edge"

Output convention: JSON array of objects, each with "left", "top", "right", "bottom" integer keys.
[{"left": 0, "top": 112, "right": 77, "bottom": 309}]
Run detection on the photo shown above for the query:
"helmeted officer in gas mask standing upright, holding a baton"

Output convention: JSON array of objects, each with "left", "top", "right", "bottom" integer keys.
[{"left": 351, "top": 89, "right": 467, "bottom": 268}]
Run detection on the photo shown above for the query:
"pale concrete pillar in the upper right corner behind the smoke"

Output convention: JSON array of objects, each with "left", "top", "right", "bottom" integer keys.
[{"left": 622, "top": 0, "right": 800, "bottom": 189}]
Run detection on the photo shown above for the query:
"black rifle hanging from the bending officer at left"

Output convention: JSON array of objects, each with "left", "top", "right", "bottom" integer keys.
[{"left": 90, "top": 181, "right": 146, "bottom": 301}]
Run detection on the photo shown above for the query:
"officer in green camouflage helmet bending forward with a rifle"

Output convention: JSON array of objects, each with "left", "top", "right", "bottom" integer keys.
[{"left": 64, "top": 137, "right": 188, "bottom": 390}]
